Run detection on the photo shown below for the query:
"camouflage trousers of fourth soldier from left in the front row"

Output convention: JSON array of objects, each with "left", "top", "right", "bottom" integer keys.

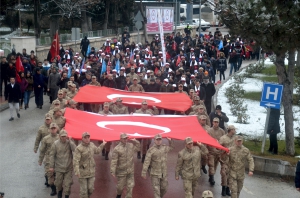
[{"left": 151, "top": 176, "right": 168, "bottom": 198}]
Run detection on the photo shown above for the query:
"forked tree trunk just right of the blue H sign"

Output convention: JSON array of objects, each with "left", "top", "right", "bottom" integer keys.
[{"left": 275, "top": 51, "right": 295, "bottom": 156}]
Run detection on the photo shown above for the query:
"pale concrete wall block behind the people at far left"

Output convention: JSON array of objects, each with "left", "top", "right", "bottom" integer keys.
[{"left": 10, "top": 36, "right": 36, "bottom": 54}]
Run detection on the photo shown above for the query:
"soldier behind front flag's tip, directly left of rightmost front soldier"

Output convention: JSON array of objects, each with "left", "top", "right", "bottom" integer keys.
[{"left": 219, "top": 125, "right": 235, "bottom": 196}]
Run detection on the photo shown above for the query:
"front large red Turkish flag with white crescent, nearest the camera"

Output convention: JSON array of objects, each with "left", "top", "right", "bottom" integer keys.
[{"left": 65, "top": 108, "right": 228, "bottom": 151}]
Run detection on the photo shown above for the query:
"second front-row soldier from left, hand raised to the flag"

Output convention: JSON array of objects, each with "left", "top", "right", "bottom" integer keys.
[{"left": 73, "top": 132, "right": 106, "bottom": 198}]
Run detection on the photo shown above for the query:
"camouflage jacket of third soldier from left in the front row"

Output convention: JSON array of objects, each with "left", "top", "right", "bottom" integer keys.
[{"left": 110, "top": 140, "right": 140, "bottom": 177}]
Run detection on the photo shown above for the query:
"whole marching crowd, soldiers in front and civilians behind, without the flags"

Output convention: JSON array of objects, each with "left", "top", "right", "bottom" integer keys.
[{"left": 1, "top": 29, "right": 255, "bottom": 198}]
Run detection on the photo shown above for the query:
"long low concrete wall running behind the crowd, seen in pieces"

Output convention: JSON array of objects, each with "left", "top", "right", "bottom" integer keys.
[{"left": 35, "top": 26, "right": 197, "bottom": 60}]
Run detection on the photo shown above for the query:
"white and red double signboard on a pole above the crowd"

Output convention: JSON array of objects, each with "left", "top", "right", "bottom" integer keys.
[{"left": 146, "top": 6, "right": 174, "bottom": 34}]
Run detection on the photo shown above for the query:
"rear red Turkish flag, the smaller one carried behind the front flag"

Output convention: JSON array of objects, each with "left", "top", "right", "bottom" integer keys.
[{"left": 74, "top": 85, "right": 192, "bottom": 111}]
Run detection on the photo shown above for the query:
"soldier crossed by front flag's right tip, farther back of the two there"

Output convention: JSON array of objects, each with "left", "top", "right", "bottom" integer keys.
[{"left": 208, "top": 118, "right": 225, "bottom": 186}]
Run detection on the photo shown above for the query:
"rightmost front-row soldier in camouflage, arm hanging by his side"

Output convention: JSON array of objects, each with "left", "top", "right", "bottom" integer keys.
[{"left": 229, "top": 135, "right": 254, "bottom": 198}]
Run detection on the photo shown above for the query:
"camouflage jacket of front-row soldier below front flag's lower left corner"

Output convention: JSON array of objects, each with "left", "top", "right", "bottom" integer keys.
[{"left": 50, "top": 139, "right": 76, "bottom": 173}]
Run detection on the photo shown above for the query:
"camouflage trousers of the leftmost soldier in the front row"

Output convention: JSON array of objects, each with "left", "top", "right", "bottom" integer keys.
[{"left": 54, "top": 170, "right": 73, "bottom": 195}]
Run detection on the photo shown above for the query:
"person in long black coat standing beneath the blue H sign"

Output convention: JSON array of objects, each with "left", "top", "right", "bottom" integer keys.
[{"left": 267, "top": 108, "right": 280, "bottom": 155}]
